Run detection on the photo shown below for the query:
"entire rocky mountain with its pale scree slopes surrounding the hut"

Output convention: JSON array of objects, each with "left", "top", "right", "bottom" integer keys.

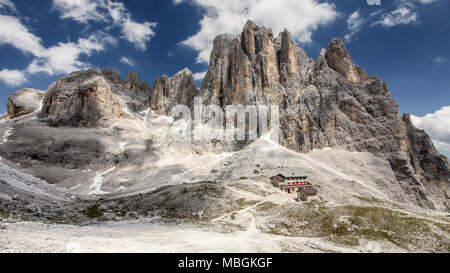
[{"left": 0, "top": 21, "right": 450, "bottom": 252}]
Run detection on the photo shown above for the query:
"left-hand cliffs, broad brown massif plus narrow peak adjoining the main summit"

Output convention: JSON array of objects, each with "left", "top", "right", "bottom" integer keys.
[{"left": 40, "top": 68, "right": 198, "bottom": 127}]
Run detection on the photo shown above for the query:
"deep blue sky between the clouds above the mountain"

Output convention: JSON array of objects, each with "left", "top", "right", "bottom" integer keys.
[{"left": 0, "top": 0, "right": 450, "bottom": 116}]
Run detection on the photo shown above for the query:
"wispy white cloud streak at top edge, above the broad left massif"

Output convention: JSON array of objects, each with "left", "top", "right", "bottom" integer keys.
[{"left": 53, "top": 0, "right": 157, "bottom": 50}]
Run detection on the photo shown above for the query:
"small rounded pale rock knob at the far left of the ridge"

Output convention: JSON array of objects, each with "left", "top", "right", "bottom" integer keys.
[{"left": 6, "top": 88, "right": 44, "bottom": 119}]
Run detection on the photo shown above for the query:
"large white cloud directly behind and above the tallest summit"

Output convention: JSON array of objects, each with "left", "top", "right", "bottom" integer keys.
[{"left": 173, "top": 0, "right": 337, "bottom": 63}]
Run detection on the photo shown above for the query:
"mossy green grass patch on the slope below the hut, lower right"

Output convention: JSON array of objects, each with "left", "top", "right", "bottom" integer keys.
[{"left": 258, "top": 203, "right": 450, "bottom": 252}]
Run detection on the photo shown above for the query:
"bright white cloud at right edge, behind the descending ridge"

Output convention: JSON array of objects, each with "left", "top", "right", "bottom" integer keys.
[{"left": 411, "top": 106, "right": 450, "bottom": 155}]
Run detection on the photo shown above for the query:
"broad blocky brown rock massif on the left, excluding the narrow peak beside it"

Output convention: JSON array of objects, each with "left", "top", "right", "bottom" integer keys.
[{"left": 39, "top": 69, "right": 151, "bottom": 127}]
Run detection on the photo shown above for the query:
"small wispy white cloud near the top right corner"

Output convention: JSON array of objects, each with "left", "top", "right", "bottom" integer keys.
[{"left": 372, "top": 2, "right": 418, "bottom": 27}]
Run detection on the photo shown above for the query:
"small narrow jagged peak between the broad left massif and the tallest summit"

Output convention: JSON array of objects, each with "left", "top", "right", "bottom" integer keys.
[{"left": 150, "top": 68, "right": 198, "bottom": 115}]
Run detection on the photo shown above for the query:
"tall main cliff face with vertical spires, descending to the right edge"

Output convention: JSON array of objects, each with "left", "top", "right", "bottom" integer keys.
[{"left": 200, "top": 21, "right": 450, "bottom": 208}]
